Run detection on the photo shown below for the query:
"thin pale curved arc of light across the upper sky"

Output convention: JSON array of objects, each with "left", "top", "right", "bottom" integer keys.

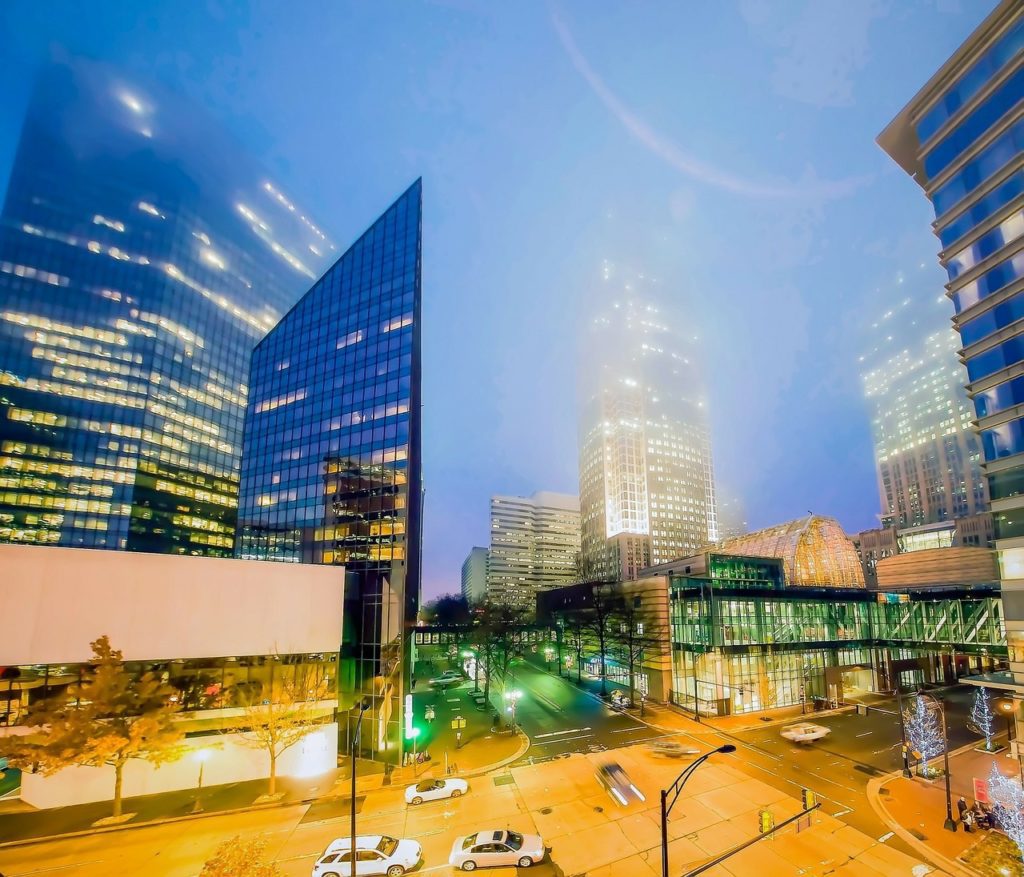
[{"left": 551, "top": 12, "right": 866, "bottom": 200}]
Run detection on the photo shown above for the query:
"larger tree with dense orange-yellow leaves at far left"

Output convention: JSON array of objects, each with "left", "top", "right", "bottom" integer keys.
[{"left": 9, "top": 636, "right": 184, "bottom": 818}]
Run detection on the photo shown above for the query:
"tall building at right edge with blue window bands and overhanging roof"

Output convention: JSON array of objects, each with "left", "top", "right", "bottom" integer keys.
[{"left": 879, "top": 0, "right": 1024, "bottom": 745}]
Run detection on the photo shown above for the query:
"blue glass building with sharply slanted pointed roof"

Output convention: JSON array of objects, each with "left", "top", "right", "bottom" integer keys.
[{"left": 237, "top": 180, "right": 422, "bottom": 757}]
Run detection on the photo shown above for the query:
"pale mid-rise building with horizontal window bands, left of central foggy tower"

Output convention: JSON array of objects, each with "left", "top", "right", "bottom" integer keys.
[{"left": 487, "top": 492, "right": 580, "bottom": 615}]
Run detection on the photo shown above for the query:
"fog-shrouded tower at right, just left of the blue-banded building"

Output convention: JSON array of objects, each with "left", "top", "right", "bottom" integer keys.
[{"left": 861, "top": 295, "right": 988, "bottom": 529}]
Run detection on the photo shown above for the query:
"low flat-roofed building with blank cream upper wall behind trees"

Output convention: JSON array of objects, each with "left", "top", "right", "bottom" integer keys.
[{"left": 0, "top": 545, "right": 344, "bottom": 807}]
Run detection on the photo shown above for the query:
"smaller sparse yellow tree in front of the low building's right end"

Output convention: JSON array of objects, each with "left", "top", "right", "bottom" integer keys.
[{"left": 240, "top": 658, "right": 329, "bottom": 795}]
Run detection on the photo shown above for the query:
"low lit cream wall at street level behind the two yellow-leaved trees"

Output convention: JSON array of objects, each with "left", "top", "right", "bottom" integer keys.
[{"left": 22, "top": 721, "right": 338, "bottom": 808}]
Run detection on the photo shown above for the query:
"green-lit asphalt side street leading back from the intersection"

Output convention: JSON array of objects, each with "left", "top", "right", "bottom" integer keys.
[{"left": 506, "top": 663, "right": 663, "bottom": 763}]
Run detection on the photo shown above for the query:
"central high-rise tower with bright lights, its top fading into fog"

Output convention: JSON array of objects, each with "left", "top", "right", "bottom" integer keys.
[{"left": 579, "top": 263, "right": 718, "bottom": 580}]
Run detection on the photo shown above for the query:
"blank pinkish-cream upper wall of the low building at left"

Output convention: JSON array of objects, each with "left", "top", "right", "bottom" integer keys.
[{"left": 0, "top": 545, "right": 345, "bottom": 667}]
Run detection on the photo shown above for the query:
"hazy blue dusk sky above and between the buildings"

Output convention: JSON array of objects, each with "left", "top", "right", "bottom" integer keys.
[{"left": 0, "top": 0, "right": 995, "bottom": 597}]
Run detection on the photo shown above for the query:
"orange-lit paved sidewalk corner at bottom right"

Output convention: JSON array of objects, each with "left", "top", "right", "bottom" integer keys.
[{"left": 867, "top": 733, "right": 1018, "bottom": 875}]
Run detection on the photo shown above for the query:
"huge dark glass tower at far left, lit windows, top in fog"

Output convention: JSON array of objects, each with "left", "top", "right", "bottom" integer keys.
[{"left": 0, "top": 61, "right": 333, "bottom": 556}]
